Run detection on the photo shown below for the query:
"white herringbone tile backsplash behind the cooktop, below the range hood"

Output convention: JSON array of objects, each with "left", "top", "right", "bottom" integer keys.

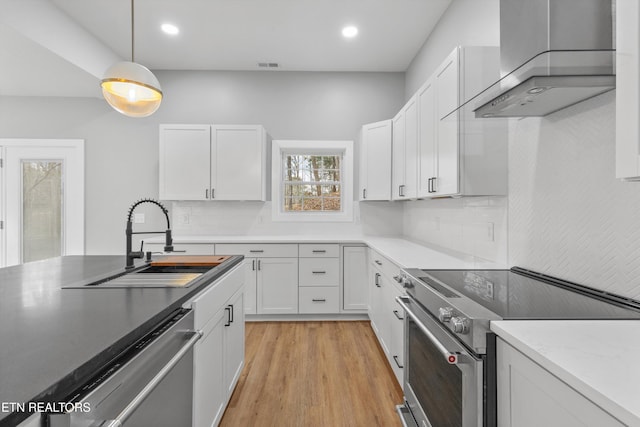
[{"left": 509, "top": 92, "right": 640, "bottom": 299}]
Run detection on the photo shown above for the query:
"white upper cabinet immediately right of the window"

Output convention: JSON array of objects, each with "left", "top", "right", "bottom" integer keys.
[{"left": 359, "top": 120, "right": 392, "bottom": 201}]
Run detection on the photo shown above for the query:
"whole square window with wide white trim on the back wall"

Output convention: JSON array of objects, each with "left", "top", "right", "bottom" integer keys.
[{"left": 272, "top": 141, "right": 353, "bottom": 221}]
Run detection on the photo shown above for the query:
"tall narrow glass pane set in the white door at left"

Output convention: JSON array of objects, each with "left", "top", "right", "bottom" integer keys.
[{"left": 21, "top": 160, "right": 64, "bottom": 262}]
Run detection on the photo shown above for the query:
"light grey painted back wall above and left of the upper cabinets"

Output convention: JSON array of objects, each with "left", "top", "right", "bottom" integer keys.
[{"left": 0, "top": 71, "right": 404, "bottom": 254}]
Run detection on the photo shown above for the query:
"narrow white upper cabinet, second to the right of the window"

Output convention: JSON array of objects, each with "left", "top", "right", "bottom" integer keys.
[{"left": 391, "top": 96, "right": 418, "bottom": 200}]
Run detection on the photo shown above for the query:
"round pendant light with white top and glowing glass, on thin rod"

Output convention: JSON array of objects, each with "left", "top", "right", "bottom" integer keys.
[{"left": 100, "top": 0, "right": 162, "bottom": 117}]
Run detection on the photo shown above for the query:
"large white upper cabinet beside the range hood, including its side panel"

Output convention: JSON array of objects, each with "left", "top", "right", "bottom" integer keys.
[{"left": 416, "top": 46, "right": 507, "bottom": 197}]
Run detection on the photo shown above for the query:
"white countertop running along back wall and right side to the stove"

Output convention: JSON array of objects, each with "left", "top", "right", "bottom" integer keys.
[{"left": 152, "top": 235, "right": 505, "bottom": 269}]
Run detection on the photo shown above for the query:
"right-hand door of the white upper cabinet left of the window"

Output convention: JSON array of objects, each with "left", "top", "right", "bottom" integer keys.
[{"left": 211, "top": 125, "right": 266, "bottom": 200}]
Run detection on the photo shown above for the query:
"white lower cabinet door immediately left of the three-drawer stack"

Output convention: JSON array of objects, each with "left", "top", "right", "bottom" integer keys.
[{"left": 257, "top": 258, "right": 298, "bottom": 314}]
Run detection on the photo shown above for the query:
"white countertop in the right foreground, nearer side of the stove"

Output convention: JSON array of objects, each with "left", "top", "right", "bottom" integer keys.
[{"left": 491, "top": 320, "right": 640, "bottom": 426}]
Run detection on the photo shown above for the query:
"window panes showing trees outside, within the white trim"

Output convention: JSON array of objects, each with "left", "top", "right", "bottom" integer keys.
[{"left": 283, "top": 154, "right": 342, "bottom": 212}]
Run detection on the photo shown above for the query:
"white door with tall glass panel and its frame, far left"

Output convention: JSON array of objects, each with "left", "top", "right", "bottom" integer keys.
[{"left": 0, "top": 139, "right": 85, "bottom": 266}]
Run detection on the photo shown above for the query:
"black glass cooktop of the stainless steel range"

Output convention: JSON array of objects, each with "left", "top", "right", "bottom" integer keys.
[{"left": 418, "top": 267, "right": 640, "bottom": 320}]
